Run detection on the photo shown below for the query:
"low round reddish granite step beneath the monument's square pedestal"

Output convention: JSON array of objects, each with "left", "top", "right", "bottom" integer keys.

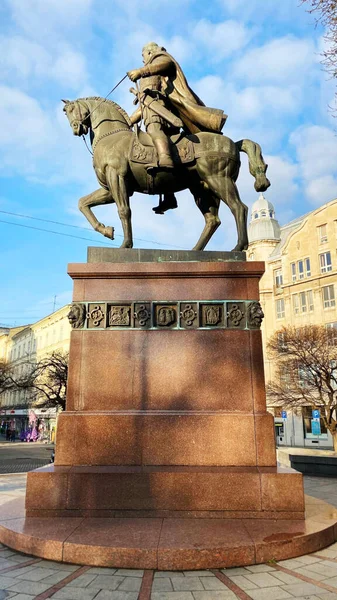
[{"left": 0, "top": 496, "right": 337, "bottom": 570}]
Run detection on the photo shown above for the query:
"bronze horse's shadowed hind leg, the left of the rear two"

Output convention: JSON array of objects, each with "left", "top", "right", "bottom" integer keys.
[{"left": 191, "top": 185, "right": 221, "bottom": 250}]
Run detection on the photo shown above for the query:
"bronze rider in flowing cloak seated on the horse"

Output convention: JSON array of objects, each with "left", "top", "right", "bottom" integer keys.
[{"left": 128, "top": 42, "right": 227, "bottom": 214}]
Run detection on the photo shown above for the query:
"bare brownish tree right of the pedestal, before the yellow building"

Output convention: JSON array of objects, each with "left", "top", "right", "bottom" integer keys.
[{"left": 267, "top": 325, "right": 337, "bottom": 450}]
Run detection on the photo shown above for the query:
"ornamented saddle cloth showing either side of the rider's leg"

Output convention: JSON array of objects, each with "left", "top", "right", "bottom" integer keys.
[{"left": 129, "top": 129, "right": 195, "bottom": 169}]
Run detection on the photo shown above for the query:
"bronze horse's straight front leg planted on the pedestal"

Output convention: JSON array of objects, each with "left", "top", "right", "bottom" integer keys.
[{"left": 106, "top": 167, "right": 133, "bottom": 248}]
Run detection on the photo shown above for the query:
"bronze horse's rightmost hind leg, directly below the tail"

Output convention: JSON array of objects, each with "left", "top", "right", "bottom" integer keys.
[{"left": 205, "top": 173, "right": 248, "bottom": 252}]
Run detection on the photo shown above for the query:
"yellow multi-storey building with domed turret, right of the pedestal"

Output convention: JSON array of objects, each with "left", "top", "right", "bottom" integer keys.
[{"left": 247, "top": 194, "right": 337, "bottom": 447}]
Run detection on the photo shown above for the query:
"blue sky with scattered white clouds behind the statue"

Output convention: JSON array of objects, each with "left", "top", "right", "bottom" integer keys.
[{"left": 0, "top": 0, "right": 337, "bottom": 326}]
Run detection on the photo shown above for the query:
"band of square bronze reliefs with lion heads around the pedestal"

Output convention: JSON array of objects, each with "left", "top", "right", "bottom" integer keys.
[{"left": 68, "top": 300, "right": 264, "bottom": 330}]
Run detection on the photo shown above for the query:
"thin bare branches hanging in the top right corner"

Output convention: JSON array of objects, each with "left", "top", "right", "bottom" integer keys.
[{"left": 302, "top": 0, "right": 337, "bottom": 112}]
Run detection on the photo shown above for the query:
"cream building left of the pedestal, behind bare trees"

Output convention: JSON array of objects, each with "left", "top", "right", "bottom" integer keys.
[{"left": 0, "top": 305, "right": 71, "bottom": 439}]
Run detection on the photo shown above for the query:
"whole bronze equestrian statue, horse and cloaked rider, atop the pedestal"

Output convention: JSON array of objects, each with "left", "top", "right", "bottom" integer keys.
[{"left": 64, "top": 43, "right": 270, "bottom": 250}]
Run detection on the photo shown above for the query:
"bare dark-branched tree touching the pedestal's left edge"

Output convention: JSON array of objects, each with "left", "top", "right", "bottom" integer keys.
[{"left": 15, "top": 352, "right": 69, "bottom": 410}]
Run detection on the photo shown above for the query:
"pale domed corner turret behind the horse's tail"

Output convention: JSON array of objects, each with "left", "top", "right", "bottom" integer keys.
[{"left": 247, "top": 194, "right": 281, "bottom": 260}]
